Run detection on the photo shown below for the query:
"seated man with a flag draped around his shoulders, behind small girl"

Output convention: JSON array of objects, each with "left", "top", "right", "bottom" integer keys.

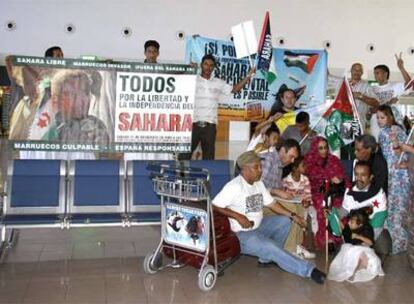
[{"left": 329, "top": 161, "right": 391, "bottom": 261}]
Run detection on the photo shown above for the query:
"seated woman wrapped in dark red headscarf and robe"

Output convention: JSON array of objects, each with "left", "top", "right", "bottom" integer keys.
[{"left": 305, "top": 136, "right": 350, "bottom": 249}]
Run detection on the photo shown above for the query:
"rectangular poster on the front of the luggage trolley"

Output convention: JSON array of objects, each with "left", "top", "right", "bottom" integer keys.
[{"left": 163, "top": 203, "right": 209, "bottom": 252}]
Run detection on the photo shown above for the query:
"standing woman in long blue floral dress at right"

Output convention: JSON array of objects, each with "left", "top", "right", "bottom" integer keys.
[{"left": 377, "top": 105, "right": 411, "bottom": 254}]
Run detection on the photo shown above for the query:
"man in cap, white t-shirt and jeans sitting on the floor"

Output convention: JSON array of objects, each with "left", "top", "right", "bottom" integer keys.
[{"left": 213, "top": 151, "right": 326, "bottom": 284}]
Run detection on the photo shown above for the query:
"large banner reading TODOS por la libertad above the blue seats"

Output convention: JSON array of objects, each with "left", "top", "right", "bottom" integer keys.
[{"left": 9, "top": 56, "right": 196, "bottom": 152}]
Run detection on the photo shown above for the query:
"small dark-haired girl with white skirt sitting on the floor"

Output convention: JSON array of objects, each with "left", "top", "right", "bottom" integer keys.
[{"left": 328, "top": 209, "right": 384, "bottom": 282}]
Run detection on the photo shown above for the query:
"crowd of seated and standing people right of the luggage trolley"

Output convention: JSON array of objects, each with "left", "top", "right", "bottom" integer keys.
[{"left": 213, "top": 55, "right": 414, "bottom": 283}]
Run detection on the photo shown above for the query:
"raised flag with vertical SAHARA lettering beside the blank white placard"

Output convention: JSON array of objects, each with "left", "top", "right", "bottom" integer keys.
[{"left": 257, "top": 12, "right": 276, "bottom": 84}]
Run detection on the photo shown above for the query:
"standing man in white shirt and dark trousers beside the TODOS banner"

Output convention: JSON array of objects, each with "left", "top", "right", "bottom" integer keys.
[{"left": 191, "top": 54, "right": 255, "bottom": 159}]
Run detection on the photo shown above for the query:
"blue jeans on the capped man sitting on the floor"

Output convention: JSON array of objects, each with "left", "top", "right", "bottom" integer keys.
[{"left": 237, "top": 215, "right": 315, "bottom": 278}]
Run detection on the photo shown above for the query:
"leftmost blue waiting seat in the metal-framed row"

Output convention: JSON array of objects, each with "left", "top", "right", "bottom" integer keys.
[{"left": 0, "top": 160, "right": 66, "bottom": 251}]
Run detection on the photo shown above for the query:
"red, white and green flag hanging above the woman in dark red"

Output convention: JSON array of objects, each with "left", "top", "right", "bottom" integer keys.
[{"left": 323, "top": 78, "right": 360, "bottom": 151}]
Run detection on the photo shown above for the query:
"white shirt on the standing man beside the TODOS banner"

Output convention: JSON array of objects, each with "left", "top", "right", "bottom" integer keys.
[{"left": 193, "top": 75, "right": 233, "bottom": 124}]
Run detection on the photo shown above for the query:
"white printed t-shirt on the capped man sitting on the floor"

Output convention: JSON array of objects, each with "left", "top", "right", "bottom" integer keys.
[{"left": 213, "top": 175, "right": 273, "bottom": 232}]
